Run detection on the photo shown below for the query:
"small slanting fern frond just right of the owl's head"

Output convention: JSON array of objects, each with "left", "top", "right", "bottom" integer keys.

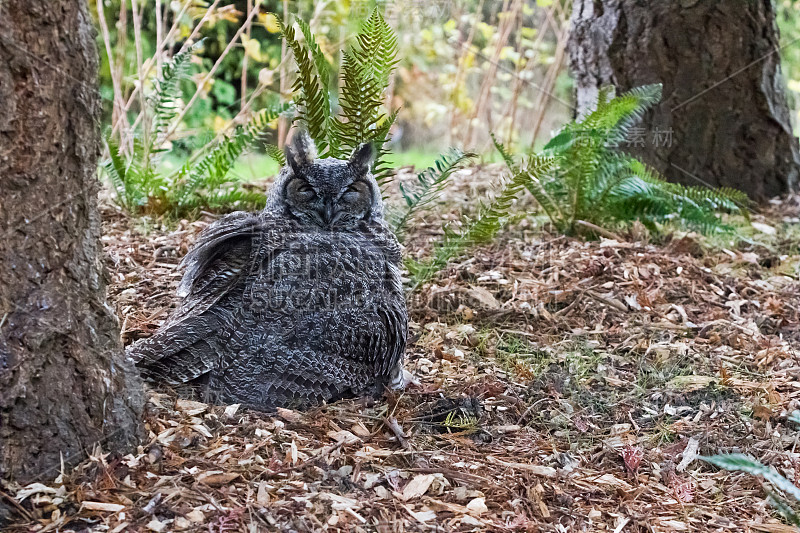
[{"left": 390, "top": 148, "right": 476, "bottom": 240}]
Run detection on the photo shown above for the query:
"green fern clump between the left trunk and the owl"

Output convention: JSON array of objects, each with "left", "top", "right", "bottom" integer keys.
[{"left": 102, "top": 45, "right": 288, "bottom": 216}]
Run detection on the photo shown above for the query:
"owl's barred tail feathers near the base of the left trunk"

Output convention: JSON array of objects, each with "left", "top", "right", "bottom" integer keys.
[{"left": 126, "top": 315, "right": 221, "bottom": 385}]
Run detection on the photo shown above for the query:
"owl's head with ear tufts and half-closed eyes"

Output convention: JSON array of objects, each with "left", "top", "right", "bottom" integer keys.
[{"left": 276, "top": 131, "right": 382, "bottom": 230}]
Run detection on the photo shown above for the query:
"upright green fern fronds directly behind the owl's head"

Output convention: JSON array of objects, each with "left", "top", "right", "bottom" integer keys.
[{"left": 270, "top": 9, "right": 397, "bottom": 184}]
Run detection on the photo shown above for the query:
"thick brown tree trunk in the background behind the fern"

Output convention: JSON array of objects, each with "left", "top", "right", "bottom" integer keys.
[{"left": 570, "top": 0, "right": 800, "bottom": 201}]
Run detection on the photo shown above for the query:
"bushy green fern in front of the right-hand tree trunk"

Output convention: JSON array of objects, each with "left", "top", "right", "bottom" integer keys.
[{"left": 495, "top": 85, "right": 747, "bottom": 235}]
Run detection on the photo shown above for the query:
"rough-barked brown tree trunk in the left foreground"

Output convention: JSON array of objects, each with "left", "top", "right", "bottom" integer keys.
[{"left": 0, "top": 0, "right": 143, "bottom": 486}]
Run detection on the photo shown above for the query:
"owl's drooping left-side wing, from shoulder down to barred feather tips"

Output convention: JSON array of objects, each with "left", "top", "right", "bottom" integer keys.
[{"left": 128, "top": 212, "right": 264, "bottom": 385}]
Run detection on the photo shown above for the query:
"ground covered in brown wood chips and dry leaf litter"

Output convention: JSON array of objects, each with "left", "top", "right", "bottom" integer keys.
[{"left": 4, "top": 167, "right": 800, "bottom": 533}]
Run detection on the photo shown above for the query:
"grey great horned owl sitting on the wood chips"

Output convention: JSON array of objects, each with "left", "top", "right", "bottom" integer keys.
[{"left": 128, "top": 132, "right": 408, "bottom": 409}]
